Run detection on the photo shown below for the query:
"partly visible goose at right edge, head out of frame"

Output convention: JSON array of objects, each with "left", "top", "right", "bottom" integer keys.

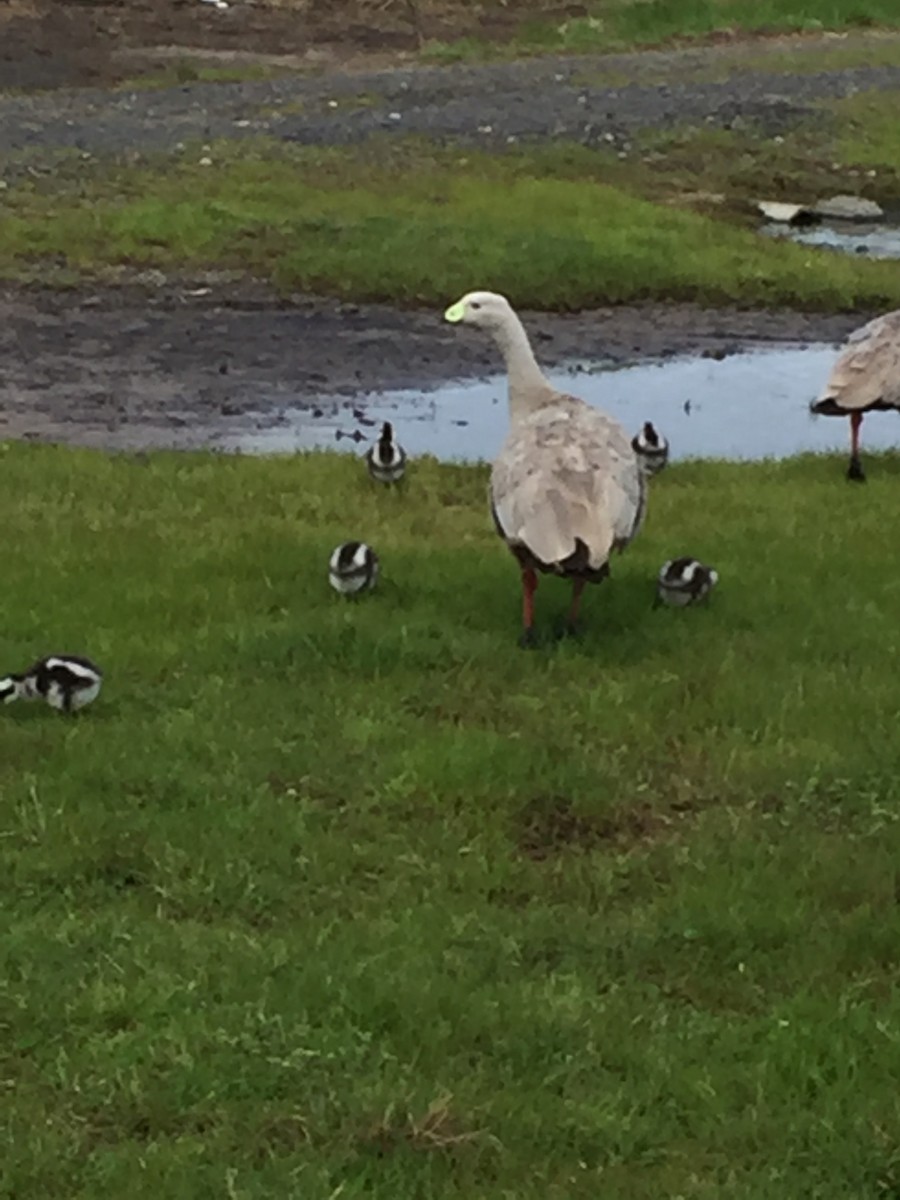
[{"left": 810, "top": 311, "right": 900, "bottom": 482}]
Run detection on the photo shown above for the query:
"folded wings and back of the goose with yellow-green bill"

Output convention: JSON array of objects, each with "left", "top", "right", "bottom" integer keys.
[{"left": 491, "top": 396, "right": 644, "bottom": 570}]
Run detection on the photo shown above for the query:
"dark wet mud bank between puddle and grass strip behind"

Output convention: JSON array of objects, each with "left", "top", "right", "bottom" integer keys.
[{"left": 0, "top": 284, "right": 865, "bottom": 449}]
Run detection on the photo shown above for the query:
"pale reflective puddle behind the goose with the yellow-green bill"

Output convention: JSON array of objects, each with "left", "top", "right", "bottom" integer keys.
[{"left": 229, "top": 346, "right": 900, "bottom": 461}]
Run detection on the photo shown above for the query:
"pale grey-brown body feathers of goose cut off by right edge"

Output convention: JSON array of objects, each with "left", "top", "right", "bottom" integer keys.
[{"left": 820, "top": 311, "right": 900, "bottom": 412}]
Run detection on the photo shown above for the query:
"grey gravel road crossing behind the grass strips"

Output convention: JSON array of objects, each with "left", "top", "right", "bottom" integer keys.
[{"left": 0, "top": 39, "right": 900, "bottom": 155}]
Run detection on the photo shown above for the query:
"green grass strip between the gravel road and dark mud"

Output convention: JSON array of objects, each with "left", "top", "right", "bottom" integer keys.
[{"left": 0, "top": 135, "right": 900, "bottom": 310}]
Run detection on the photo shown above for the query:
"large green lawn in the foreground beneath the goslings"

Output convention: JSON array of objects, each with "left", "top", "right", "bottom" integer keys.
[{"left": 0, "top": 445, "right": 900, "bottom": 1200}]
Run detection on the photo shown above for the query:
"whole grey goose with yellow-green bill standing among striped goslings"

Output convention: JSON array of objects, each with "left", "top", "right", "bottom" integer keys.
[{"left": 444, "top": 292, "right": 647, "bottom": 646}]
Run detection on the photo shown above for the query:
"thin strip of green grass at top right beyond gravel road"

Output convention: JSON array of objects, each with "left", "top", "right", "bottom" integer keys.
[{"left": 425, "top": 0, "right": 900, "bottom": 61}]
